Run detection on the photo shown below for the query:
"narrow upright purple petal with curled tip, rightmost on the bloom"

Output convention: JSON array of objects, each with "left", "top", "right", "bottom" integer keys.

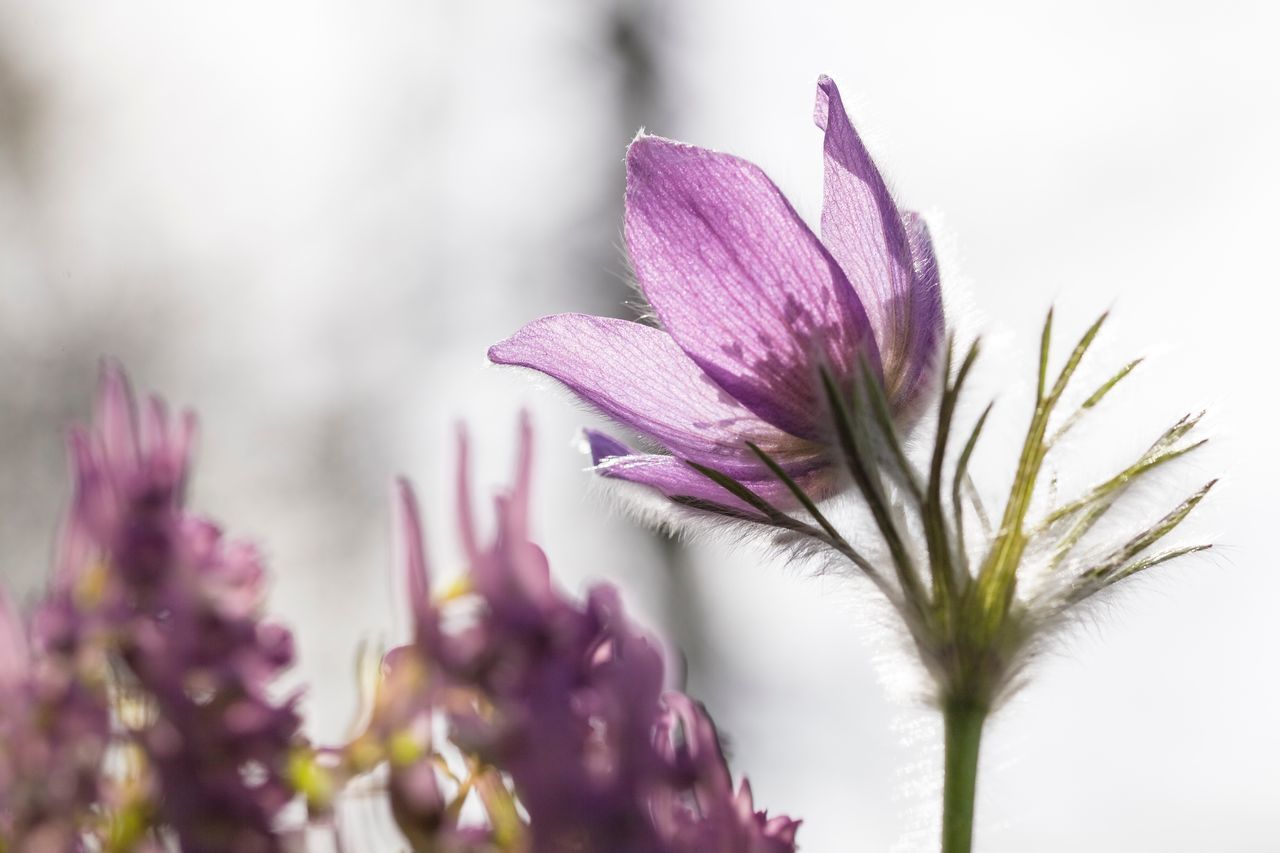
[{"left": 814, "top": 77, "right": 942, "bottom": 410}]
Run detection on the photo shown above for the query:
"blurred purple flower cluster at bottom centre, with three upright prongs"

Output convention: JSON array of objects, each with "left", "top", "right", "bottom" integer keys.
[{"left": 375, "top": 421, "right": 797, "bottom": 853}]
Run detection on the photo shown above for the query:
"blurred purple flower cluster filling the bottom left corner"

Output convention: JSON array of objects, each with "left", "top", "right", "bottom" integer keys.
[{"left": 0, "top": 366, "right": 300, "bottom": 850}]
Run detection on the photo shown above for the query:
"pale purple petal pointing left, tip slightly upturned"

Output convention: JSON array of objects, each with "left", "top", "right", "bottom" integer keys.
[{"left": 489, "top": 314, "right": 817, "bottom": 474}]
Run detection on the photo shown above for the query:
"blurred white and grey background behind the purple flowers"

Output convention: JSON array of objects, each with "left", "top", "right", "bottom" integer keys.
[{"left": 0, "top": 0, "right": 1280, "bottom": 853}]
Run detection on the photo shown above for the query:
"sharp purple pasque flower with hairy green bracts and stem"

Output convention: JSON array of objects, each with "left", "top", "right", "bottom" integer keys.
[{"left": 490, "top": 78, "right": 1212, "bottom": 853}]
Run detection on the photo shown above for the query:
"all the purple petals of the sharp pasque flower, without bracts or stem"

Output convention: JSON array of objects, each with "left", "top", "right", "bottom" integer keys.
[{"left": 489, "top": 77, "right": 943, "bottom": 503}]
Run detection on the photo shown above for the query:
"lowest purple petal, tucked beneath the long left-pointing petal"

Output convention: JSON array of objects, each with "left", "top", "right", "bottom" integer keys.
[{"left": 589, "top": 433, "right": 835, "bottom": 515}]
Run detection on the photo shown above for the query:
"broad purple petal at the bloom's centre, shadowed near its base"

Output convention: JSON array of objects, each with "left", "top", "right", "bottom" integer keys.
[{"left": 626, "top": 136, "right": 879, "bottom": 439}]
